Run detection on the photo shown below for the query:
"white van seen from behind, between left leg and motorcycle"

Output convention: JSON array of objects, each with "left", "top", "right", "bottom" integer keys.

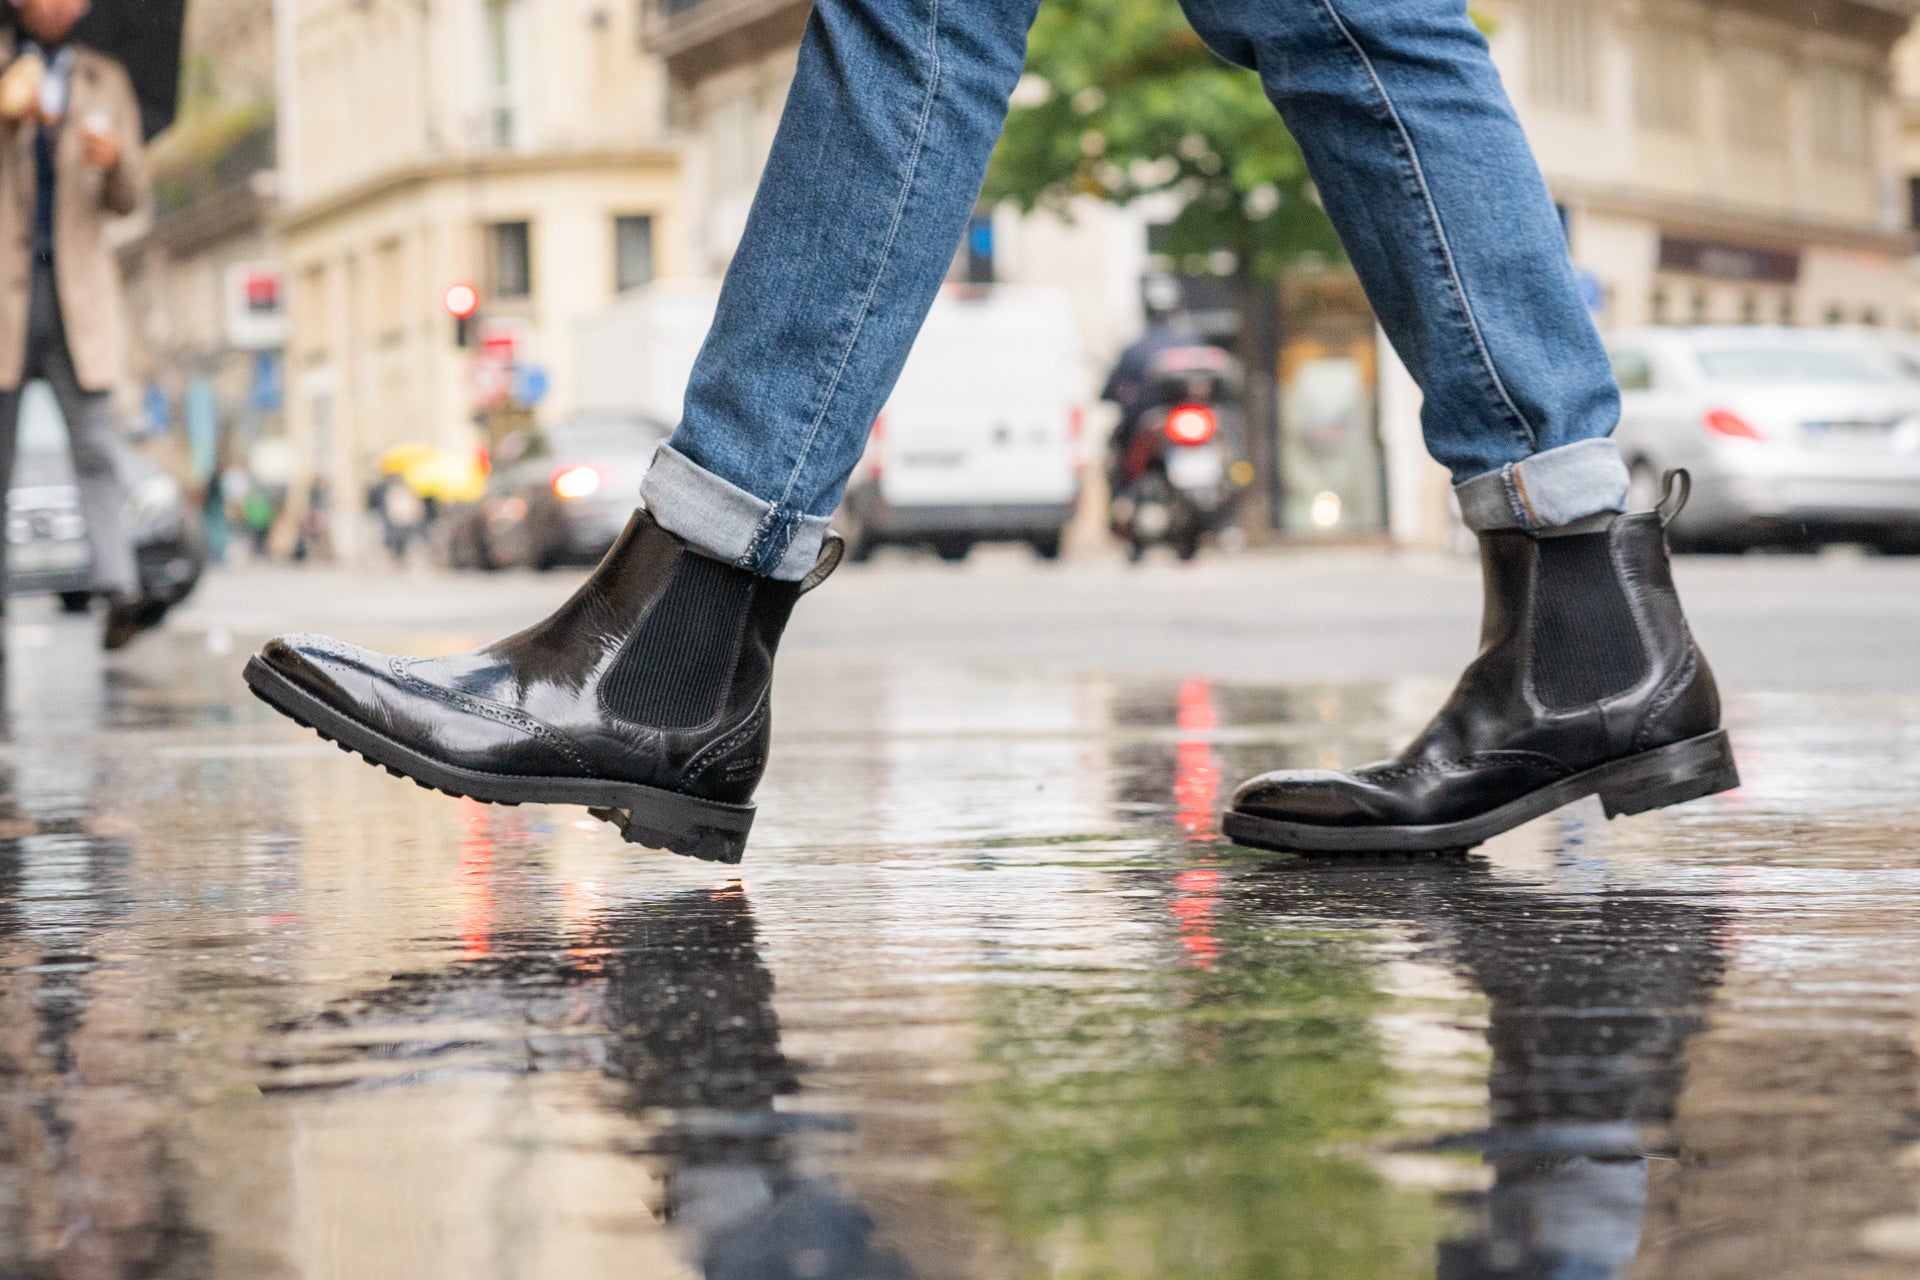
[{"left": 835, "top": 284, "right": 1085, "bottom": 560}]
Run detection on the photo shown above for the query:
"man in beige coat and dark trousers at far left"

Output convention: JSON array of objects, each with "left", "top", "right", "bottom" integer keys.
[{"left": 0, "top": 0, "right": 154, "bottom": 649}]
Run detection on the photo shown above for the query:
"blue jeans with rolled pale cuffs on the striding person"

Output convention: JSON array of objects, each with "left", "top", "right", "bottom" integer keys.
[{"left": 641, "top": 0, "right": 1626, "bottom": 580}]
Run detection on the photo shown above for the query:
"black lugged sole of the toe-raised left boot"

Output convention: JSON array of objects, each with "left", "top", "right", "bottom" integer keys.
[{"left": 244, "top": 658, "right": 755, "bottom": 864}]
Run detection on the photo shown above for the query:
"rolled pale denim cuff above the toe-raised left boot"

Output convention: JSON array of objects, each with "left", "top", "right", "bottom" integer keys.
[{"left": 639, "top": 445, "right": 828, "bottom": 581}]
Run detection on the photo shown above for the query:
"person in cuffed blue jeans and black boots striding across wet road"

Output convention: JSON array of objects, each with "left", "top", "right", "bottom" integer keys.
[{"left": 248, "top": 0, "right": 1738, "bottom": 860}]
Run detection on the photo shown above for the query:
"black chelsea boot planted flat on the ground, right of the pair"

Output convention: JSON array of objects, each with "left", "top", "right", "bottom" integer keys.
[{"left": 1225, "top": 472, "right": 1740, "bottom": 852}]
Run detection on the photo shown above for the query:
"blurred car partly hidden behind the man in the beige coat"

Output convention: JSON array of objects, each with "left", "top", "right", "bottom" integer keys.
[{"left": 8, "top": 382, "right": 207, "bottom": 622}]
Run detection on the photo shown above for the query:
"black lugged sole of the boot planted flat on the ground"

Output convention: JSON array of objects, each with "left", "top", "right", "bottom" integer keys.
[{"left": 1221, "top": 729, "right": 1740, "bottom": 854}]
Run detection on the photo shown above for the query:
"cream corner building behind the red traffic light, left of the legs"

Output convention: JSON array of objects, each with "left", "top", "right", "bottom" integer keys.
[{"left": 278, "top": 0, "right": 685, "bottom": 553}]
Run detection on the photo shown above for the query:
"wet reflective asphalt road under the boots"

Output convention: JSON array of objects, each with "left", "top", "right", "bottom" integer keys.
[{"left": 0, "top": 557, "right": 1920, "bottom": 1280}]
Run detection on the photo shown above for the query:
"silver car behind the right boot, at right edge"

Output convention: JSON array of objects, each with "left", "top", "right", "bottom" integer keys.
[{"left": 1607, "top": 326, "right": 1920, "bottom": 553}]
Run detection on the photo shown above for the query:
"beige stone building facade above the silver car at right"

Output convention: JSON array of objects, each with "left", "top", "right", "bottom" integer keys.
[{"left": 1488, "top": 0, "right": 1920, "bottom": 335}]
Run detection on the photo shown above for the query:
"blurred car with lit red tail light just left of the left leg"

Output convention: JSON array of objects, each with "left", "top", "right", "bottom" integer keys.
[{"left": 445, "top": 411, "right": 670, "bottom": 570}]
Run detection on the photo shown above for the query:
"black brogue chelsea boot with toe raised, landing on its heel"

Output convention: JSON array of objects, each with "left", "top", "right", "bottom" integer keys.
[{"left": 246, "top": 510, "right": 841, "bottom": 862}]
